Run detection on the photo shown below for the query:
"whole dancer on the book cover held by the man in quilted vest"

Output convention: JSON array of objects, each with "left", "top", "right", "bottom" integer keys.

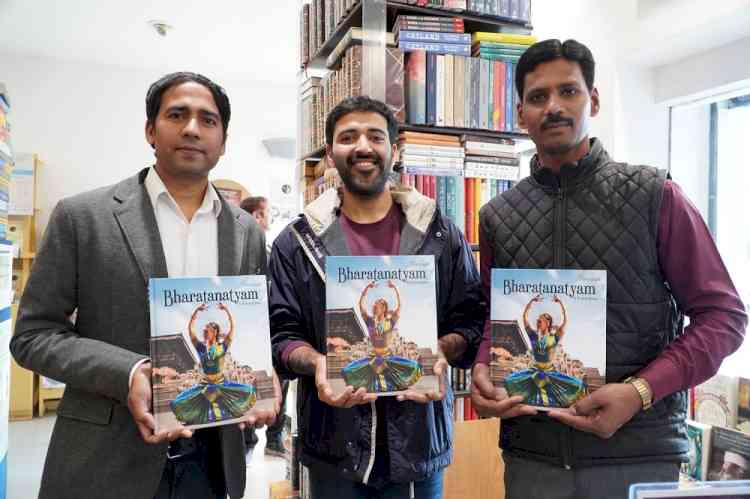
[{"left": 505, "top": 295, "right": 586, "bottom": 407}]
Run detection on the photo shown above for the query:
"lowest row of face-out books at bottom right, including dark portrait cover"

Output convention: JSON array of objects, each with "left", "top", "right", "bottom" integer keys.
[{"left": 681, "top": 421, "right": 750, "bottom": 481}]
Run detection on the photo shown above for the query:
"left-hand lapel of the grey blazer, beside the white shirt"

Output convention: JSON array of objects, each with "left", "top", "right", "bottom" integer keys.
[{"left": 114, "top": 169, "right": 168, "bottom": 284}]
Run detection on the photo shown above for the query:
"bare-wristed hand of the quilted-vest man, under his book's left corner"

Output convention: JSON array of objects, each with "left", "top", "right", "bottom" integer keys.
[{"left": 471, "top": 363, "right": 537, "bottom": 419}]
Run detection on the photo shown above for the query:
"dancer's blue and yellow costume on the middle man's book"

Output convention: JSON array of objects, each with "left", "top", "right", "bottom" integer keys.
[{"left": 341, "top": 317, "right": 422, "bottom": 393}]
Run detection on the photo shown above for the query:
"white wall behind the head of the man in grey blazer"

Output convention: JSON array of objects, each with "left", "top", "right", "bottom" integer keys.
[{"left": 0, "top": 53, "right": 297, "bottom": 242}]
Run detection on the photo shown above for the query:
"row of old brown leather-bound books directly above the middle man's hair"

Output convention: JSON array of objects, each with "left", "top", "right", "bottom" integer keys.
[{"left": 301, "top": 45, "right": 405, "bottom": 156}]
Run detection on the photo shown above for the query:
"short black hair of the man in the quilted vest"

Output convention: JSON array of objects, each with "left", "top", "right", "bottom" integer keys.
[{"left": 516, "top": 38, "right": 595, "bottom": 100}]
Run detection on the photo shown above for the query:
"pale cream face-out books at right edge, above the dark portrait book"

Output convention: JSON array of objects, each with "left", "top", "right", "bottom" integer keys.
[{"left": 690, "top": 374, "right": 750, "bottom": 435}]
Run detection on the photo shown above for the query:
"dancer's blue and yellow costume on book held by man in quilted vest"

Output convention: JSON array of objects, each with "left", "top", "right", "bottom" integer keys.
[{"left": 505, "top": 331, "right": 586, "bottom": 407}]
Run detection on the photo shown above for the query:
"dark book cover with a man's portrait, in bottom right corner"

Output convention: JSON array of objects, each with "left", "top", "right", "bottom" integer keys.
[{"left": 707, "top": 426, "right": 750, "bottom": 481}]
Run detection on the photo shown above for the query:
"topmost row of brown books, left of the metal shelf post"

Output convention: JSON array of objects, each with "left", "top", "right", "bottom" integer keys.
[{"left": 300, "top": 0, "right": 357, "bottom": 66}]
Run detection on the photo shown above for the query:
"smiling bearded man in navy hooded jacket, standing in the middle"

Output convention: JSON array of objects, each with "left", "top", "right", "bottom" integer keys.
[{"left": 270, "top": 97, "right": 486, "bottom": 499}]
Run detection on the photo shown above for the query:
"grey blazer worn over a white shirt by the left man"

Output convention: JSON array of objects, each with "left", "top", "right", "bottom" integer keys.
[{"left": 11, "top": 169, "right": 266, "bottom": 499}]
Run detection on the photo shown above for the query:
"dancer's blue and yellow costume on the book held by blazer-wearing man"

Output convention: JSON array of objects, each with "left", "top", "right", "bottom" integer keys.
[{"left": 170, "top": 342, "right": 257, "bottom": 425}]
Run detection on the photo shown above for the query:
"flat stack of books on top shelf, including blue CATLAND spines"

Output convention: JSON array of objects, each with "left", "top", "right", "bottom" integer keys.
[{"left": 393, "top": 16, "right": 471, "bottom": 56}]
